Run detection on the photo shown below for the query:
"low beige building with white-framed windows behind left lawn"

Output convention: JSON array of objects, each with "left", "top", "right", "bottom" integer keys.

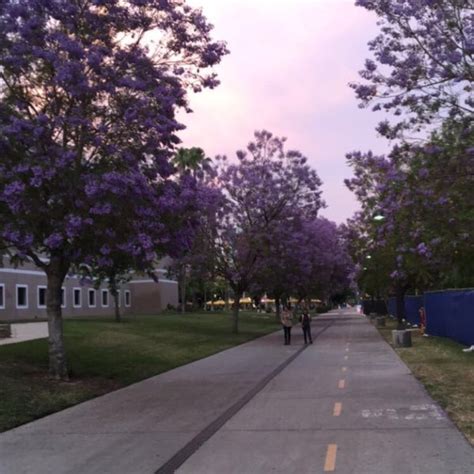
[{"left": 0, "top": 259, "right": 178, "bottom": 321}]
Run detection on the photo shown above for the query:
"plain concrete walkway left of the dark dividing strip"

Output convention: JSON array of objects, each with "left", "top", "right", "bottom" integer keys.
[{"left": 0, "top": 312, "right": 327, "bottom": 474}]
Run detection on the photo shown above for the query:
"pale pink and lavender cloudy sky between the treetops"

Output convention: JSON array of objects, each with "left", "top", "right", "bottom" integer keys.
[{"left": 176, "top": 0, "right": 388, "bottom": 223}]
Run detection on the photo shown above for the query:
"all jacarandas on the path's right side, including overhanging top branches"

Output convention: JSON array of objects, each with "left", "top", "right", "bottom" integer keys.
[{"left": 346, "top": 0, "right": 474, "bottom": 323}]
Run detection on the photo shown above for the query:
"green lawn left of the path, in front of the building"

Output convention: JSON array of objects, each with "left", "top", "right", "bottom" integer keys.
[{"left": 0, "top": 312, "right": 279, "bottom": 431}]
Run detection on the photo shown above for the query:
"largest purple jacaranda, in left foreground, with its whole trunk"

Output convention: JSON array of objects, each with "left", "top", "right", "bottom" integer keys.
[{"left": 0, "top": 0, "right": 226, "bottom": 378}]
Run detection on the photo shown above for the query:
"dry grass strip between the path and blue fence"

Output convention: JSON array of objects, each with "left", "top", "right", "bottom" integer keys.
[{"left": 379, "top": 320, "right": 474, "bottom": 445}]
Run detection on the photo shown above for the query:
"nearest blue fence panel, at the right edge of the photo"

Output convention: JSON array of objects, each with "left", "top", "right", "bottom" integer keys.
[{"left": 425, "top": 290, "right": 474, "bottom": 345}]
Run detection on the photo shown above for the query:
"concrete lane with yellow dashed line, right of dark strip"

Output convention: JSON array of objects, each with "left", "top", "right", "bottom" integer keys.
[{"left": 178, "top": 312, "right": 474, "bottom": 474}]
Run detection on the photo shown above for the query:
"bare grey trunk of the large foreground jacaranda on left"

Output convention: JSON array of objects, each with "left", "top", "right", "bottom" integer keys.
[{"left": 46, "top": 257, "right": 69, "bottom": 380}]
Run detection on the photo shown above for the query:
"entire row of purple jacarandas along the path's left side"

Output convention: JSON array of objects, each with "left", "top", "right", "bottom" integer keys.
[{"left": 0, "top": 0, "right": 351, "bottom": 378}]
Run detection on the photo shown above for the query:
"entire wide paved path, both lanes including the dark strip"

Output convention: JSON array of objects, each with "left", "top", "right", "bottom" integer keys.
[{"left": 0, "top": 312, "right": 474, "bottom": 474}]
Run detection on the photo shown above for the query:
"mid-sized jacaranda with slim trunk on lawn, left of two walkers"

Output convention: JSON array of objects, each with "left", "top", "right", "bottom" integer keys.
[{"left": 214, "top": 131, "right": 323, "bottom": 332}]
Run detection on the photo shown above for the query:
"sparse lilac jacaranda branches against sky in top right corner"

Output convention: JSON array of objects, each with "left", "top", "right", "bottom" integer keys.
[{"left": 352, "top": 0, "right": 474, "bottom": 137}]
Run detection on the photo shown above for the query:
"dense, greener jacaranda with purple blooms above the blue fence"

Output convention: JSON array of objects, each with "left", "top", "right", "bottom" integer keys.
[{"left": 346, "top": 122, "right": 474, "bottom": 328}]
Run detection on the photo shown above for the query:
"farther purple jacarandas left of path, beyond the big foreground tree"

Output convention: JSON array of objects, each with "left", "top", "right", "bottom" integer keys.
[{"left": 175, "top": 131, "right": 352, "bottom": 332}]
